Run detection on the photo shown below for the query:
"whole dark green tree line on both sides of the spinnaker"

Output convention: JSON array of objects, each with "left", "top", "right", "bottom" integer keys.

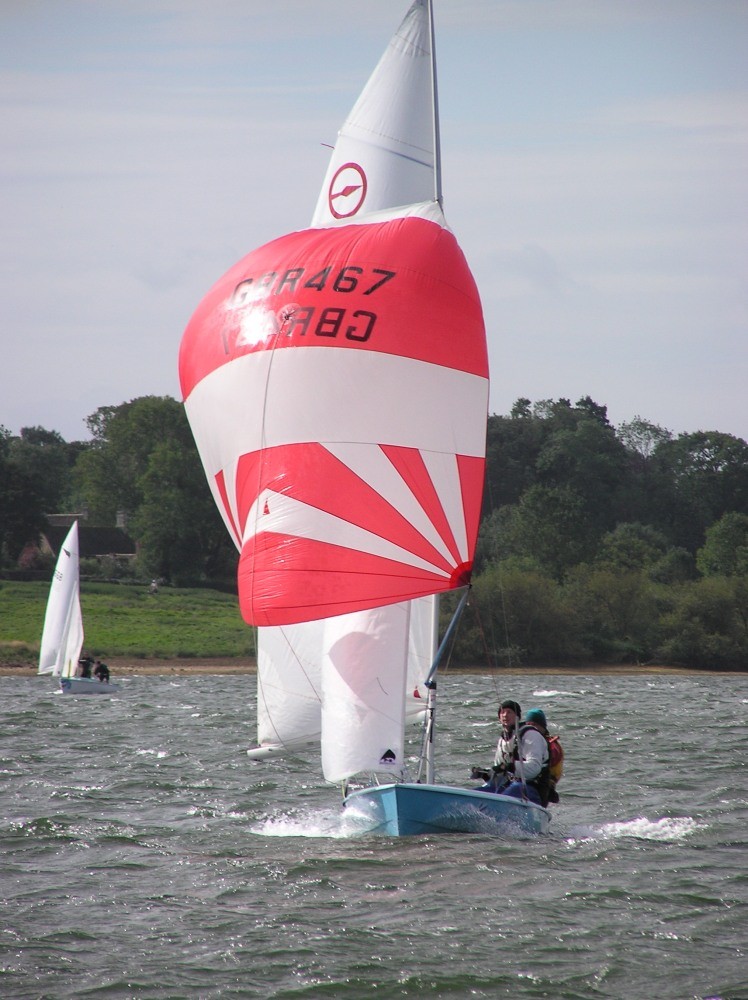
[{"left": 0, "top": 396, "right": 748, "bottom": 670}]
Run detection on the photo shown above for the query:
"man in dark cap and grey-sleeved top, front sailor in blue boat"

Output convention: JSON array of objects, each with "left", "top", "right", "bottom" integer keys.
[{"left": 471, "top": 699, "right": 549, "bottom": 805}]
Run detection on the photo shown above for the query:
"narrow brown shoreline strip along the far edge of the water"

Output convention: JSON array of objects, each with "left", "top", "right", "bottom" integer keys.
[{"left": 0, "top": 656, "right": 747, "bottom": 678}]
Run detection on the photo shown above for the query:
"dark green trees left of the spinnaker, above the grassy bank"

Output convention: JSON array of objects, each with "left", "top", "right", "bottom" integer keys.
[{"left": 0, "top": 396, "right": 236, "bottom": 585}]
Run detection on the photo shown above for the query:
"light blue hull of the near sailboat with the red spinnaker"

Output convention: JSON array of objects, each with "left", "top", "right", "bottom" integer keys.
[{"left": 344, "top": 783, "right": 550, "bottom": 837}]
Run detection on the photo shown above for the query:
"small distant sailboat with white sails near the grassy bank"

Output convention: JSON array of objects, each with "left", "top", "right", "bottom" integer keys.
[{"left": 38, "top": 521, "right": 117, "bottom": 694}]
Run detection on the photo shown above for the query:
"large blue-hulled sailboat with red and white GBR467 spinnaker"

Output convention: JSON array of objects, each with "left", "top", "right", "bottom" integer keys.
[{"left": 179, "top": 0, "right": 549, "bottom": 836}]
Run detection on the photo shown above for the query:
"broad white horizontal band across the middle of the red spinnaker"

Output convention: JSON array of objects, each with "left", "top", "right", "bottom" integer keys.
[{"left": 185, "top": 347, "right": 488, "bottom": 468}]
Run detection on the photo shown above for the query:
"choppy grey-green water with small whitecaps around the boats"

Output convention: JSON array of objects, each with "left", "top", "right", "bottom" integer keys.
[{"left": 0, "top": 675, "right": 748, "bottom": 1000}]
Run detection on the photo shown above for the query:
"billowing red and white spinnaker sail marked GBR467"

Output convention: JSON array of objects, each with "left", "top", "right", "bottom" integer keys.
[{"left": 179, "top": 203, "right": 488, "bottom": 625}]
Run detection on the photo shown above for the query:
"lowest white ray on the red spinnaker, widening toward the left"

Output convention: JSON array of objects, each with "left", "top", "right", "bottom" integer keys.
[{"left": 247, "top": 490, "right": 456, "bottom": 580}]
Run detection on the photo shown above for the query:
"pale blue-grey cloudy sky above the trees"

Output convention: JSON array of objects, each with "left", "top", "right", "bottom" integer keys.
[{"left": 0, "top": 0, "right": 748, "bottom": 441}]
